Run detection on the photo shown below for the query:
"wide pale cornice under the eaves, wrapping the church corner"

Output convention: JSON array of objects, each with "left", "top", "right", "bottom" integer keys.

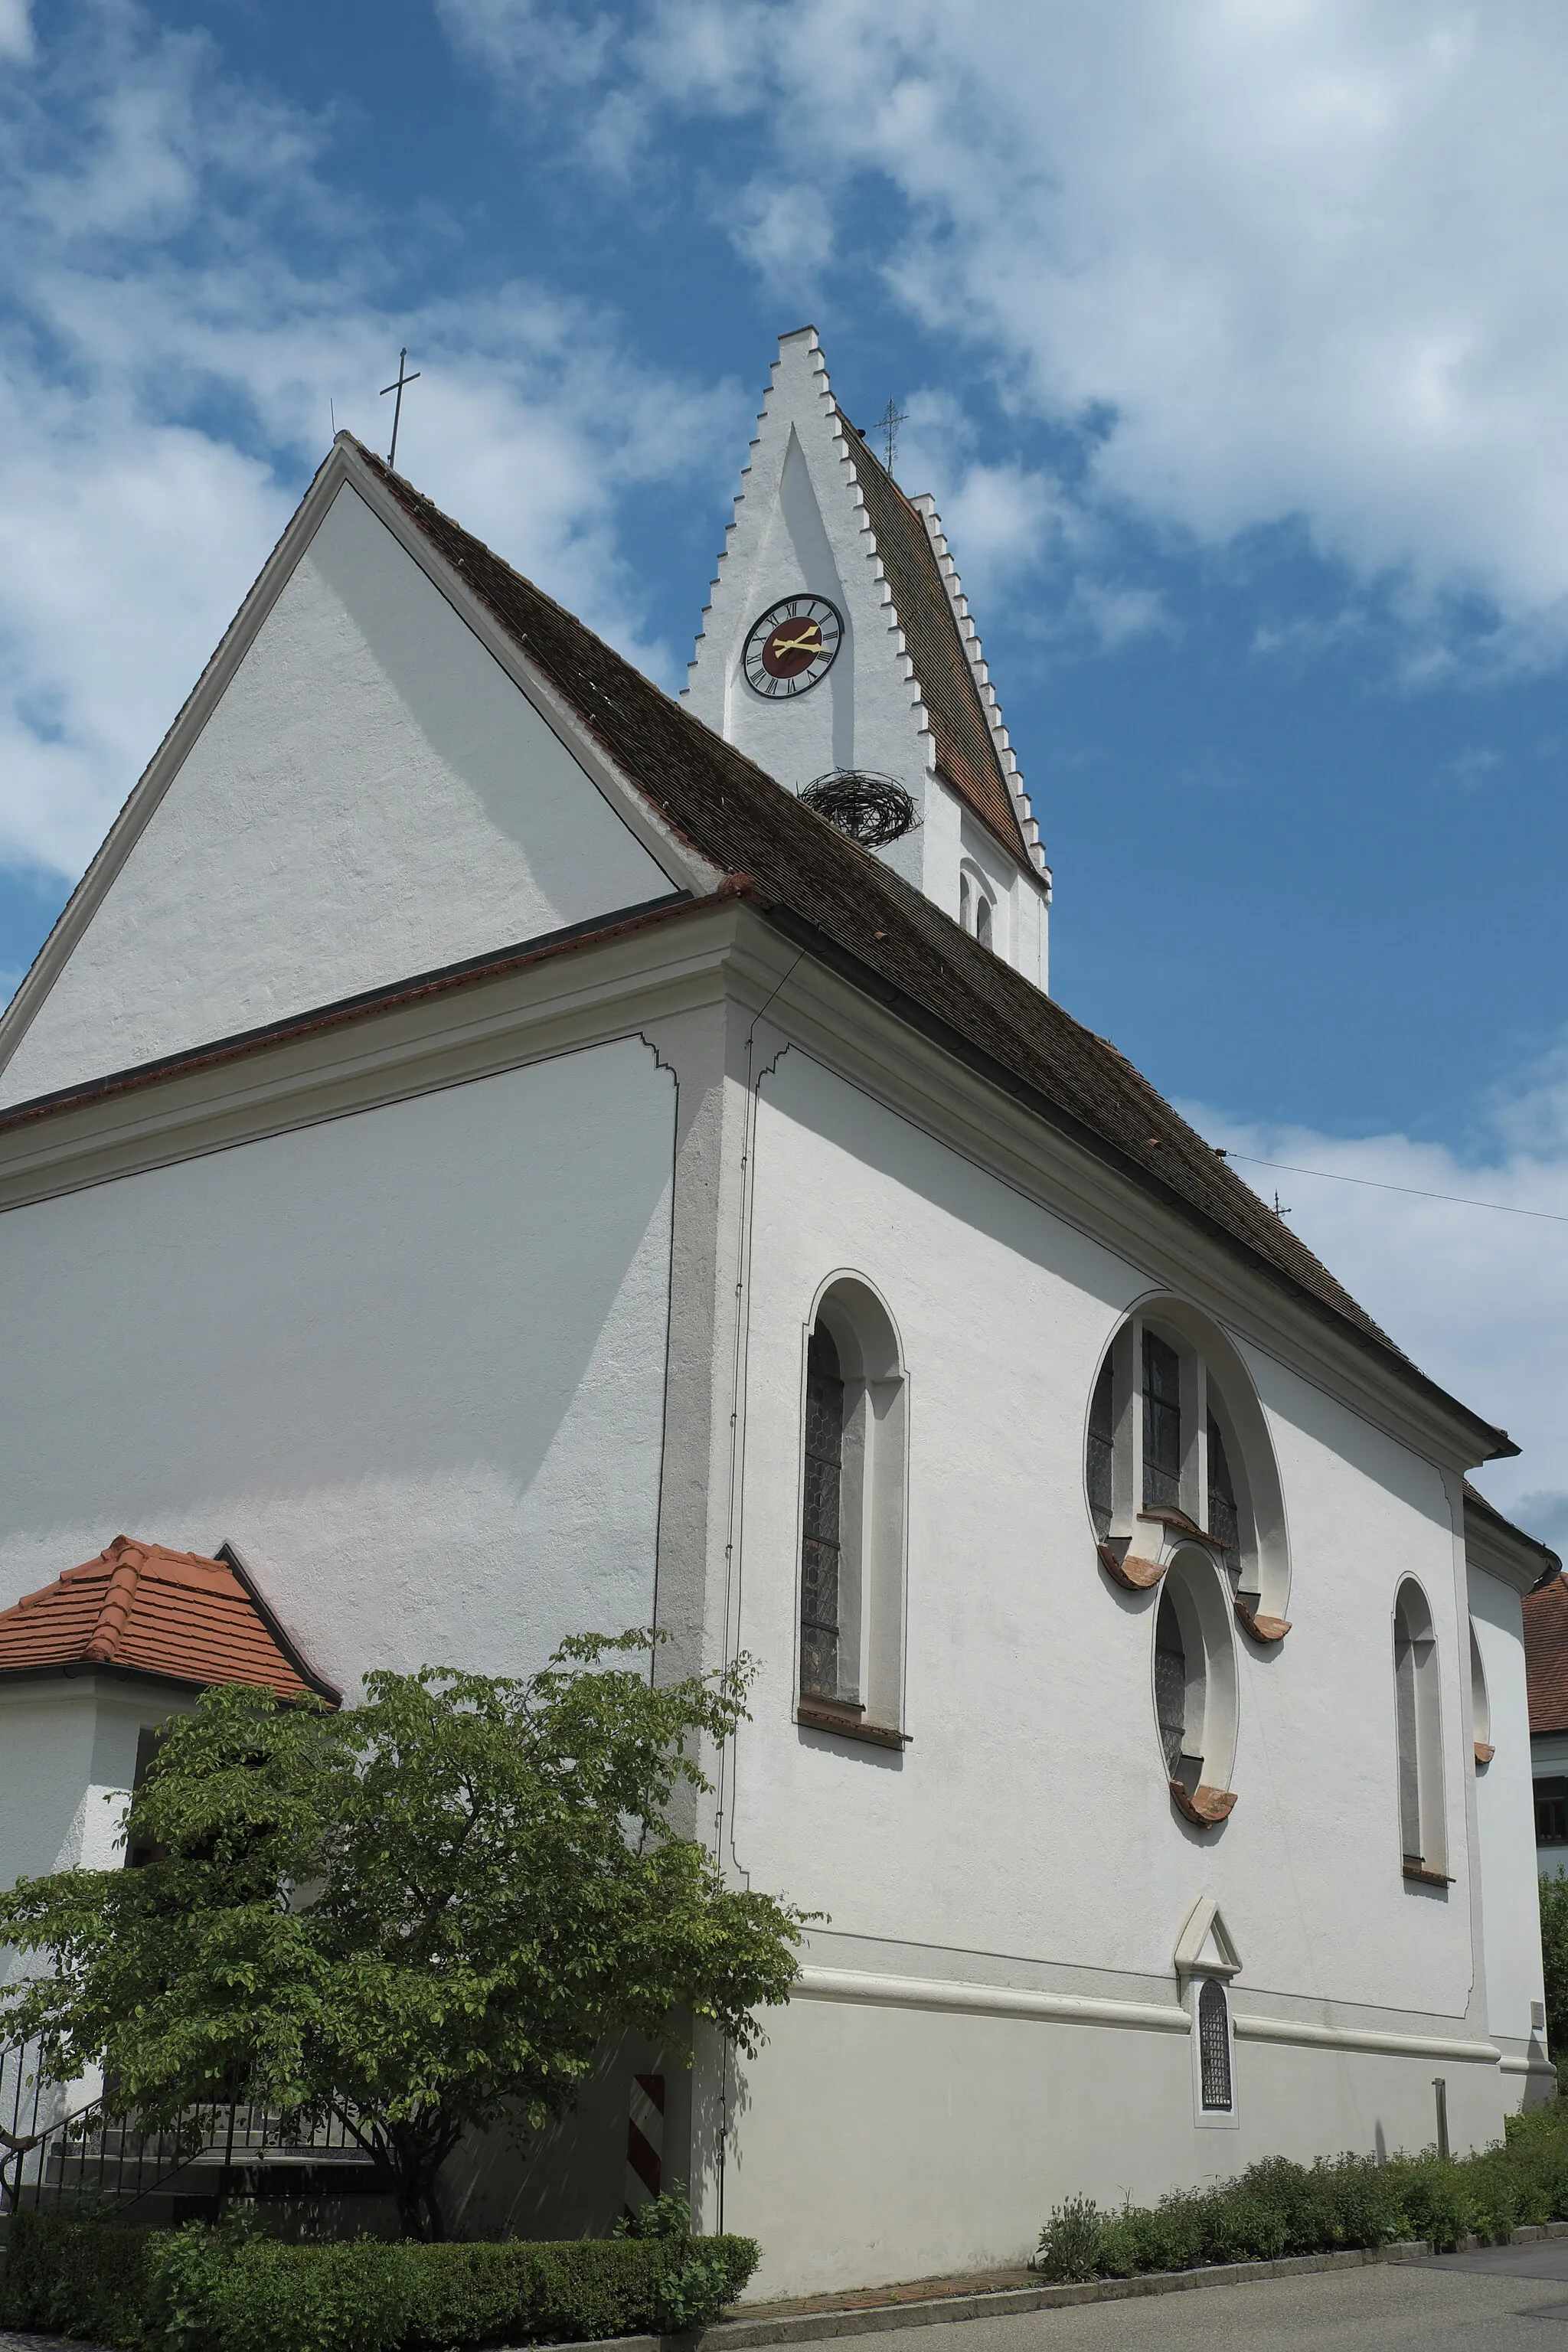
[{"left": 0, "top": 899, "right": 1504, "bottom": 1468}]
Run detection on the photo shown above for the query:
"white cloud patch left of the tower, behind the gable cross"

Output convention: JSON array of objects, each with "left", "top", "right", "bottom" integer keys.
[{"left": 0, "top": 0, "right": 750, "bottom": 875}]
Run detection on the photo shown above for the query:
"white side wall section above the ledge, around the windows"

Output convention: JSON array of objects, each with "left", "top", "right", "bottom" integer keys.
[{"left": 736, "top": 1051, "right": 1472, "bottom": 2020}]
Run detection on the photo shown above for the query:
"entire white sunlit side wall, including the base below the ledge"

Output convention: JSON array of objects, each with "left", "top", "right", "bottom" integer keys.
[{"left": 727, "top": 1049, "right": 1511, "bottom": 2288}]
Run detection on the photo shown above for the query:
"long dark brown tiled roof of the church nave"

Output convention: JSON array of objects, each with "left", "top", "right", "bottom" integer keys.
[{"left": 360, "top": 447, "right": 1516, "bottom": 1453}]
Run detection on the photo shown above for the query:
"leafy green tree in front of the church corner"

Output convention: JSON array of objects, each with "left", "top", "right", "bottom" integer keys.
[{"left": 0, "top": 1632, "right": 806, "bottom": 2236}]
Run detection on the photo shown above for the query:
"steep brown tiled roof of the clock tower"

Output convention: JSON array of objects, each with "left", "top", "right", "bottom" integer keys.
[{"left": 839, "top": 410, "right": 1030, "bottom": 865}]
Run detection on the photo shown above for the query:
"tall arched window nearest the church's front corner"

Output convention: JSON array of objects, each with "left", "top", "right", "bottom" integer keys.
[{"left": 797, "top": 1275, "right": 907, "bottom": 1747}]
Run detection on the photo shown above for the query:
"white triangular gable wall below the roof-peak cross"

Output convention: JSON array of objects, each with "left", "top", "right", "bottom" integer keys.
[{"left": 0, "top": 485, "right": 672, "bottom": 1103}]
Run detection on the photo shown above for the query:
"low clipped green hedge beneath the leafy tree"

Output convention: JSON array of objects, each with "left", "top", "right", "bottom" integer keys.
[{"left": 0, "top": 2211, "right": 757, "bottom": 2352}]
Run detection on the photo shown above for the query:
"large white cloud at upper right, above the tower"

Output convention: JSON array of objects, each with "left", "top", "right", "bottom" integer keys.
[{"left": 442, "top": 0, "right": 1568, "bottom": 680}]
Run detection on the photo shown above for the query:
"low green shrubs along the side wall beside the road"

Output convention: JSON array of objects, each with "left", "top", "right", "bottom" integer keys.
[{"left": 1034, "top": 2100, "right": 1568, "bottom": 2279}]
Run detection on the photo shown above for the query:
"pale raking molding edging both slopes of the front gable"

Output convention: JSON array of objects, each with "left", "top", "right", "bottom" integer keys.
[{"left": 0, "top": 433, "right": 722, "bottom": 1091}]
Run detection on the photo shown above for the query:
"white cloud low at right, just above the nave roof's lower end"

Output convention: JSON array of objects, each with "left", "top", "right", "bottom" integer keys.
[{"left": 1185, "top": 1047, "right": 1568, "bottom": 1547}]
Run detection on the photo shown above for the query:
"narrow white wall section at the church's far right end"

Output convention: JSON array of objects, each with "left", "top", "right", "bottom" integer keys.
[{"left": 1469, "top": 1566, "right": 1544, "bottom": 2047}]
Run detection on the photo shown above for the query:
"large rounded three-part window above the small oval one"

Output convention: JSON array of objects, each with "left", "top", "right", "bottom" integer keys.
[{"left": 1083, "top": 1298, "right": 1291, "bottom": 1644}]
